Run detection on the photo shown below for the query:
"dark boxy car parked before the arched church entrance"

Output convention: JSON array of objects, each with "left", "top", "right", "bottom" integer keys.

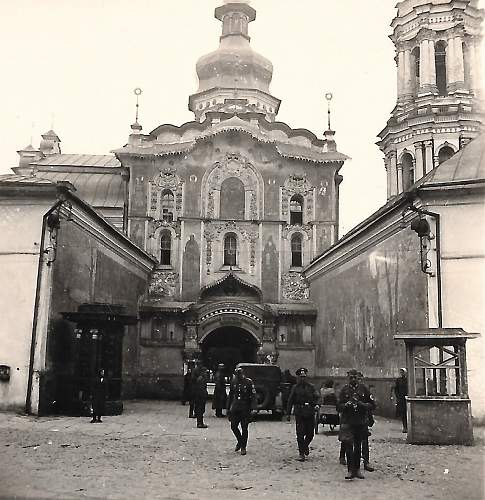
[{"left": 237, "top": 363, "right": 283, "bottom": 418}]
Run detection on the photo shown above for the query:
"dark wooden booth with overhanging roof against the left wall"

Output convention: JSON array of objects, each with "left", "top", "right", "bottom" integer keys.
[{"left": 61, "top": 303, "right": 137, "bottom": 416}]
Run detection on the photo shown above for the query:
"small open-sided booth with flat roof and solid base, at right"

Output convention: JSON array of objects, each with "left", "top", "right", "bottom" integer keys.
[{"left": 394, "top": 328, "right": 480, "bottom": 445}]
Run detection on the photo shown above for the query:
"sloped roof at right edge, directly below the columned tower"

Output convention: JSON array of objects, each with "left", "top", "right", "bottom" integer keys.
[{"left": 415, "top": 133, "right": 485, "bottom": 187}]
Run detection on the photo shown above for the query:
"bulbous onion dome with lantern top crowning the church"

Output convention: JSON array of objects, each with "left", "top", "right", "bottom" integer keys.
[{"left": 189, "top": 1, "right": 280, "bottom": 120}]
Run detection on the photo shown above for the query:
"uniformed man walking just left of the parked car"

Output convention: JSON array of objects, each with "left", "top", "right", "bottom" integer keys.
[{"left": 227, "top": 368, "right": 256, "bottom": 455}]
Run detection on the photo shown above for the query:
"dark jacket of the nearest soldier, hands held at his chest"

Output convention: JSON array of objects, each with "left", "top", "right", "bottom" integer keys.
[{"left": 337, "top": 384, "right": 375, "bottom": 425}]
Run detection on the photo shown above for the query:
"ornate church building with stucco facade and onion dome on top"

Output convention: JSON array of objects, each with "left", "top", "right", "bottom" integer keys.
[{"left": 115, "top": 2, "right": 347, "bottom": 393}]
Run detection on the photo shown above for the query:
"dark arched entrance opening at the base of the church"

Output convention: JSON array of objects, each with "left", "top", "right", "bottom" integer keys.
[{"left": 200, "top": 326, "right": 258, "bottom": 372}]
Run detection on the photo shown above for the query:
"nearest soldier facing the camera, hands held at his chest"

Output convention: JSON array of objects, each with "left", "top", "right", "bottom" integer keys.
[{"left": 337, "top": 370, "right": 374, "bottom": 479}]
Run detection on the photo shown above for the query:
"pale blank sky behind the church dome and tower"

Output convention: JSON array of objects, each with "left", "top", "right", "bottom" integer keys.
[{"left": 0, "top": 0, "right": 406, "bottom": 235}]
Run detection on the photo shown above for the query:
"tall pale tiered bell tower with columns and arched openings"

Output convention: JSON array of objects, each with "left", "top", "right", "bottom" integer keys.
[{"left": 377, "top": 0, "right": 484, "bottom": 199}]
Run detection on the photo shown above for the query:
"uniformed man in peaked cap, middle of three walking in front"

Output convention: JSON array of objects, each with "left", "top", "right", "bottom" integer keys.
[{"left": 287, "top": 368, "right": 318, "bottom": 462}]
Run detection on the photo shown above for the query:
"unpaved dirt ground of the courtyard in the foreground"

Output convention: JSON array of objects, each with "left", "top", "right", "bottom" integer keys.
[{"left": 0, "top": 401, "right": 485, "bottom": 500}]
